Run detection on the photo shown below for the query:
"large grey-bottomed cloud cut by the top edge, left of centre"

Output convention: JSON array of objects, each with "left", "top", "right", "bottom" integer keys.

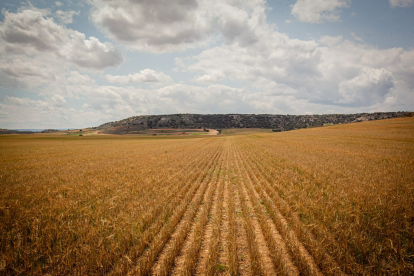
[{"left": 91, "top": 0, "right": 265, "bottom": 53}]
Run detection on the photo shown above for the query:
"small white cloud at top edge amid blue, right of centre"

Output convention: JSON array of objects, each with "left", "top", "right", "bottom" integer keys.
[{"left": 291, "top": 0, "right": 351, "bottom": 23}]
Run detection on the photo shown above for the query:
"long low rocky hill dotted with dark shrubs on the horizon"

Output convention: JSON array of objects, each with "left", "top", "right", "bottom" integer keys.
[{"left": 96, "top": 112, "right": 411, "bottom": 134}]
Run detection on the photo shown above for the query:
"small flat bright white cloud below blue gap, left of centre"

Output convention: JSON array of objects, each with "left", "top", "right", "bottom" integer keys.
[{"left": 106, "top": 69, "right": 172, "bottom": 84}]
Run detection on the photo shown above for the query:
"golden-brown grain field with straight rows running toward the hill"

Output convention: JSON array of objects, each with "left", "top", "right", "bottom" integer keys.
[{"left": 0, "top": 118, "right": 414, "bottom": 275}]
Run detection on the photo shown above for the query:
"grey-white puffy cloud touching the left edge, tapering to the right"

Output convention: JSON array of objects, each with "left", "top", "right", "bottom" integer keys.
[{"left": 0, "top": 10, "right": 123, "bottom": 69}]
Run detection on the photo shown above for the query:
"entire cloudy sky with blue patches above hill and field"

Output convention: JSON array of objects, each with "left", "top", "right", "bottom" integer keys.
[{"left": 0, "top": 0, "right": 414, "bottom": 129}]
